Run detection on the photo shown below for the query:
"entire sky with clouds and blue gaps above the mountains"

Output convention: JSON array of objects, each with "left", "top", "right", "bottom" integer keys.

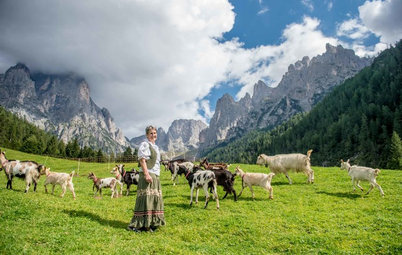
[{"left": 0, "top": 0, "right": 402, "bottom": 138}]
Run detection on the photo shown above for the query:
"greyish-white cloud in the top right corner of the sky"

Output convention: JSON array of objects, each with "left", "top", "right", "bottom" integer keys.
[{"left": 359, "top": 0, "right": 402, "bottom": 44}]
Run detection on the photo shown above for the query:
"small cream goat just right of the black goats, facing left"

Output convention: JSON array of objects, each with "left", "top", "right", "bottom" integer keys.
[{"left": 235, "top": 166, "right": 275, "bottom": 199}]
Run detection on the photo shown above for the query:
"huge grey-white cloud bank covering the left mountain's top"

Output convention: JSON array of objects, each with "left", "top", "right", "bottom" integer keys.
[{"left": 0, "top": 0, "right": 234, "bottom": 137}]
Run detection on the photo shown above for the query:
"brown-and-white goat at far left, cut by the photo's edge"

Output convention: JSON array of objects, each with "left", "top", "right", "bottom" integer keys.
[{"left": 0, "top": 150, "right": 44, "bottom": 193}]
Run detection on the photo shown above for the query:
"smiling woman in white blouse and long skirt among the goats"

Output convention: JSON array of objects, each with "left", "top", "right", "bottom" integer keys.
[{"left": 127, "top": 126, "right": 165, "bottom": 232}]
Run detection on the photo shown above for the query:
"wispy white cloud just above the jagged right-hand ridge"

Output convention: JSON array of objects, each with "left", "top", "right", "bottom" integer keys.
[{"left": 228, "top": 17, "right": 340, "bottom": 99}]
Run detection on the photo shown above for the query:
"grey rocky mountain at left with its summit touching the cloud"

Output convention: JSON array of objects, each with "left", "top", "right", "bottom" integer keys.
[{"left": 0, "top": 64, "right": 129, "bottom": 152}]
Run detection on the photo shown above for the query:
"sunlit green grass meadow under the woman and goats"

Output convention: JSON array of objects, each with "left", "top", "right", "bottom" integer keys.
[{"left": 0, "top": 150, "right": 402, "bottom": 254}]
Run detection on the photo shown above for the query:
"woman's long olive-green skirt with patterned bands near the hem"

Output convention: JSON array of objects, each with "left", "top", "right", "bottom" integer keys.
[{"left": 129, "top": 173, "right": 166, "bottom": 229}]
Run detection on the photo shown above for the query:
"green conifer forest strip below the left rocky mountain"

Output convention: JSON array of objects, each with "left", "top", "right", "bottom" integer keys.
[{"left": 0, "top": 106, "right": 137, "bottom": 162}]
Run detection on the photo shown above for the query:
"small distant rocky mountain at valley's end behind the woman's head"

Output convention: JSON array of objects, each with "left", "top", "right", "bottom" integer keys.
[{"left": 130, "top": 119, "right": 207, "bottom": 158}]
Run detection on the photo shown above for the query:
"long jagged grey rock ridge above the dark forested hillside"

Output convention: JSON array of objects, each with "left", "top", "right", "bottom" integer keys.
[{"left": 200, "top": 44, "right": 372, "bottom": 148}]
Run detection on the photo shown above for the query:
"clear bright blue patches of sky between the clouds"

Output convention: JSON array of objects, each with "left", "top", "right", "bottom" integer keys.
[{"left": 201, "top": 0, "right": 384, "bottom": 112}]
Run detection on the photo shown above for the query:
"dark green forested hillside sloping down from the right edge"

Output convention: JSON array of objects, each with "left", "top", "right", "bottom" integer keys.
[{"left": 204, "top": 41, "right": 402, "bottom": 168}]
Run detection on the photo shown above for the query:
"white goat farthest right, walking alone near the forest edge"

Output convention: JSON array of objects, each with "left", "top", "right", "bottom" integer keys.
[{"left": 341, "top": 159, "right": 384, "bottom": 196}]
